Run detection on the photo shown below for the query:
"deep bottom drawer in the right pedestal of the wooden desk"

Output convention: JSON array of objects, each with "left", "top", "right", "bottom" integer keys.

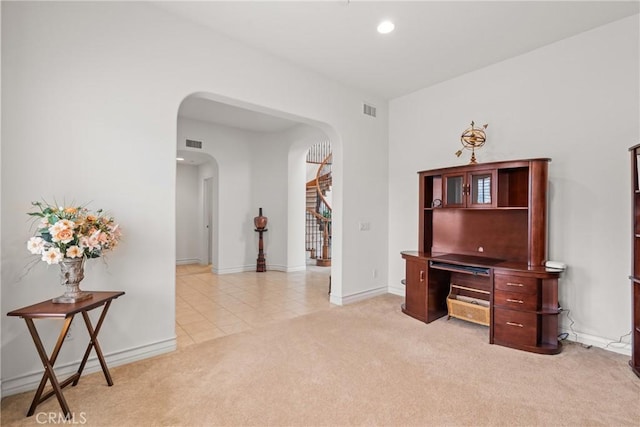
[{"left": 493, "top": 308, "right": 538, "bottom": 346}]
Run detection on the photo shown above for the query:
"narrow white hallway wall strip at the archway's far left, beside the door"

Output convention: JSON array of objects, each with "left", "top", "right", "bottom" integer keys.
[{"left": 176, "top": 164, "right": 202, "bottom": 264}]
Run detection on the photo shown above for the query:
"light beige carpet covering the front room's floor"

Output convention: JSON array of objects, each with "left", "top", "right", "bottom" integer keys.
[{"left": 2, "top": 295, "right": 640, "bottom": 426}]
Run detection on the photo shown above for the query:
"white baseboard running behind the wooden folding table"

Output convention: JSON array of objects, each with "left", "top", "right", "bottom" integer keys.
[{"left": 1, "top": 337, "right": 177, "bottom": 397}]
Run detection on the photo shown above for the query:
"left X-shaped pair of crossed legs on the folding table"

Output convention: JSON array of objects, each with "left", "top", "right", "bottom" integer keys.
[{"left": 24, "top": 315, "right": 73, "bottom": 419}]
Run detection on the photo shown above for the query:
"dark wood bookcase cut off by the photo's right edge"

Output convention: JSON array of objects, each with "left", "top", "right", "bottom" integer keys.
[{"left": 629, "top": 145, "right": 640, "bottom": 377}]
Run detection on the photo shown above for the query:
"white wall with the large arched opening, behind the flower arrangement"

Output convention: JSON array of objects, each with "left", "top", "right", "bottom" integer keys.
[{"left": 0, "top": 2, "right": 388, "bottom": 394}]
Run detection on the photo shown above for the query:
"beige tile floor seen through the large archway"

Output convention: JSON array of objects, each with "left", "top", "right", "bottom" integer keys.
[{"left": 176, "top": 264, "right": 333, "bottom": 349}]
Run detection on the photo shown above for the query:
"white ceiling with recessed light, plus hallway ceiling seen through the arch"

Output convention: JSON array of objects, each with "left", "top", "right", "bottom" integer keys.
[{"left": 168, "top": 0, "right": 640, "bottom": 162}]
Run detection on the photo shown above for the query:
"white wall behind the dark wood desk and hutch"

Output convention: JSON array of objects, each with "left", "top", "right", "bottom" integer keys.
[{"left": 389, "top": 16, "right": 640, "bottom": 349}]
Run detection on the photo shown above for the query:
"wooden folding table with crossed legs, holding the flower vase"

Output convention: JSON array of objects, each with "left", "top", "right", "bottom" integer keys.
[{"left": 7, "top": 291, "right": 124, "bottom": 419}]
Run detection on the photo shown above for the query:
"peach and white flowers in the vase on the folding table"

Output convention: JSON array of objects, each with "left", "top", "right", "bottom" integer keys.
[{"left": 27, "top": 202, "right": 121, "bottom": 265}]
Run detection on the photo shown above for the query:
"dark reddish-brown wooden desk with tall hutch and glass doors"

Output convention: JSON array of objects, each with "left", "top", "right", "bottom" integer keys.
[{"left": 402, "top": 159, "right": 561, "bottom": 354}]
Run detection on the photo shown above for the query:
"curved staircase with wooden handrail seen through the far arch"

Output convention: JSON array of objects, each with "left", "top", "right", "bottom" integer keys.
[{"left": 305, "top": 142, "right": 332, "bottom": 267}]
